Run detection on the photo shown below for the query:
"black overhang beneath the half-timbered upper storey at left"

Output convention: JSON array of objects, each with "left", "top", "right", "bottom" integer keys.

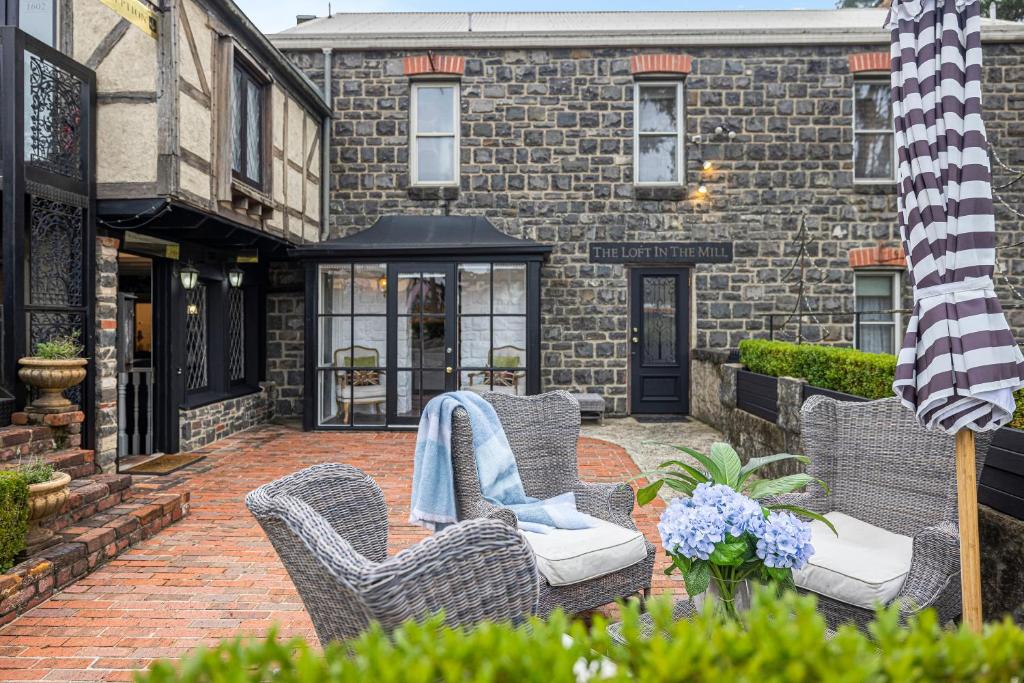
[{"left": 96, "top": 198, "right": 292, "bottom": 256}]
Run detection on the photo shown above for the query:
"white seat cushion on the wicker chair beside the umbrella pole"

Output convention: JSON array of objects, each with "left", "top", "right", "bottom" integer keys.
[{"left": 793, "top": 512, "right": 913, "bottom": 609}]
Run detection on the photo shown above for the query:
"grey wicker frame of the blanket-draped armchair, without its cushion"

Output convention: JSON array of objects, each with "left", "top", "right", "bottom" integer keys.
[{"left": 452, "top": 391, "right": 655, "bottom": 615}]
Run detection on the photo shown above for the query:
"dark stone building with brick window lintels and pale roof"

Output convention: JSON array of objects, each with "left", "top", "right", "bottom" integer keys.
[{"left": 271, "top": 9, "right": 1024, "bottom": 427}]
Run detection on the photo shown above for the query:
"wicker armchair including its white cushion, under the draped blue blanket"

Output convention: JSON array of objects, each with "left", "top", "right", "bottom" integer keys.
[{"left": 452, "top": 391, "right": 654, "bottom": 614}]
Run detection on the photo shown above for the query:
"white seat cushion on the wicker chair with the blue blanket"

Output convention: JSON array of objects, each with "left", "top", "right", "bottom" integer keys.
[{"left": 522, "top": 521, "right": 647, "bottom": 586}]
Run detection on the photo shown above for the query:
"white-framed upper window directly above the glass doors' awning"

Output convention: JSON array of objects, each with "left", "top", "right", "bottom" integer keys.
[{"left": 409, "top": 81, "right": 460, "bottom": 185}]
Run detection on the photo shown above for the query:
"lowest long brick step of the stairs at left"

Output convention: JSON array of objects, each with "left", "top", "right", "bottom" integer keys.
[{"left": 0, "top": 489, "right": 189, "bottom": 625}]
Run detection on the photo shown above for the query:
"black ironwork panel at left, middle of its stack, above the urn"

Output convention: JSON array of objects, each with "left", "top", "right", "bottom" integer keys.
[{"left": 29, "top": 196, "right": 85, "bottom": 306}]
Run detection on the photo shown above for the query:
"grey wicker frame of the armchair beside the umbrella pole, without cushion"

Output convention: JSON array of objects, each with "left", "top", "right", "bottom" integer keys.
[{"left": 775, "top": 395, "right": 990, "bottom": 629}]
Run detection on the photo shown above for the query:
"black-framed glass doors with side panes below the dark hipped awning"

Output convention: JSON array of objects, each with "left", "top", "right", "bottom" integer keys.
[{"left": 306, "top": 260, "right": 540, "bottom": 429}]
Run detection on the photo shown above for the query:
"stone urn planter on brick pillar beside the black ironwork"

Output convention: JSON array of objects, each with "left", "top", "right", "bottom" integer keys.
[{"left": 17, "top": 332, "right": 88, "bottom": 411}]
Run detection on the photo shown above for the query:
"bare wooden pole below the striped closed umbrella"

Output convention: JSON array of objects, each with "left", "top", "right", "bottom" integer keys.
[{"left": 956, "top": 429, "right": 982, "bottom": 633}]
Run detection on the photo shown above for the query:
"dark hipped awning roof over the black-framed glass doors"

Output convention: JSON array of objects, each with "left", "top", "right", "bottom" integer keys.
[{"left": 288, "top": 216, "right": 551, "bottom": 259}]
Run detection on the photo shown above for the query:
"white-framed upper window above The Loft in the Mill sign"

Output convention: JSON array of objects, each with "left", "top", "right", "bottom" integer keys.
[{"left": 633, "top": 81, "right": 686, "bottom": 185}]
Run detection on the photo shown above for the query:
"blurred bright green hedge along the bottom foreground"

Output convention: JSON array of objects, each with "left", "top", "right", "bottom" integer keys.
[{"left": 136, "top": 592, "right": 1024, "bottom": 683}]
